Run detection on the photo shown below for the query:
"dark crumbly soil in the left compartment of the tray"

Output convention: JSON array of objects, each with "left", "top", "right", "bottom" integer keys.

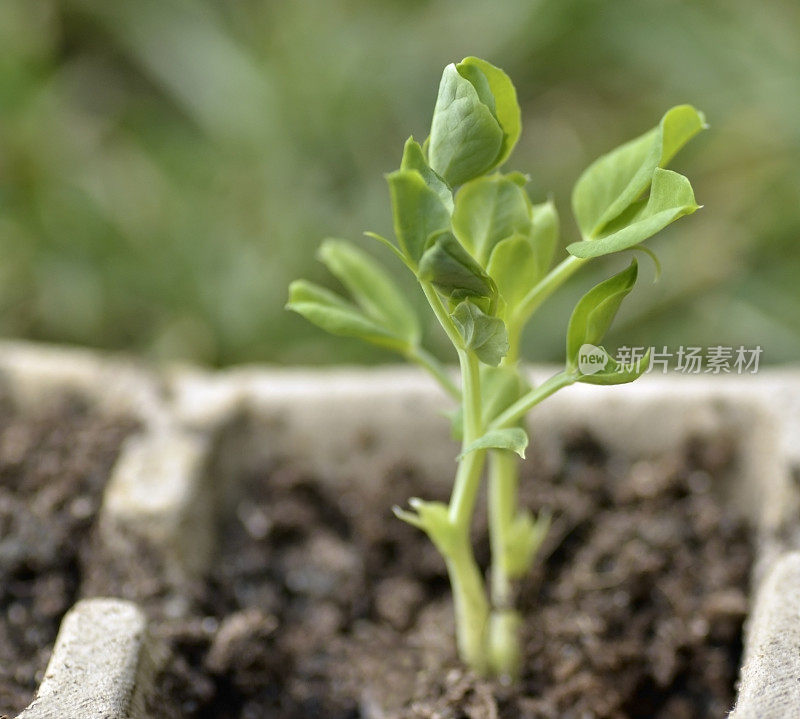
[{"left": 0, "top": 397, "right": 135, "bottom": 716}]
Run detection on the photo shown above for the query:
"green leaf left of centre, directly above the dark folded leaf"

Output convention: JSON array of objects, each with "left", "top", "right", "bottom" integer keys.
[{"left": 386, "top": 170, "right": 450, "bottom": 266}]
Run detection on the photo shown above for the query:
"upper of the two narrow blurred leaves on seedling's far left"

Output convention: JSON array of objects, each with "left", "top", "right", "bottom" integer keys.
[{"left": 318, "top": 239, "right": 421, "bottom": 345}]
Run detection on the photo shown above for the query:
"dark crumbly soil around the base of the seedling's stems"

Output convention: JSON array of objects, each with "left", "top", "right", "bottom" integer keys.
[{"left": 151, "top": 437, "right": 751, "bottom": 719}]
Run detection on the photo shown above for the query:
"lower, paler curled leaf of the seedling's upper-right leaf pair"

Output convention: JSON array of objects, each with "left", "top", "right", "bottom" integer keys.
[{"left": 567, "top": 169, "right": 700, "bottom": 257}]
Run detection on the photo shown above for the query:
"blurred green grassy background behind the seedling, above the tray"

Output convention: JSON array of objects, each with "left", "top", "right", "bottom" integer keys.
[{"left": 0, "top": 0, "right": 800, "bottom": 365}]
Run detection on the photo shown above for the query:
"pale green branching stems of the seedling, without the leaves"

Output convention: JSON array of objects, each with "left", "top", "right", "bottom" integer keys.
[{"left": 414, "top": 268, "right": 583, "bottom": 677}]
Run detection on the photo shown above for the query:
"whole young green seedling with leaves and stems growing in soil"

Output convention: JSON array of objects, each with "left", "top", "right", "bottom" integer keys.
[{"left": 287, "top": 57, "right": 706, "bottom": 679}]
